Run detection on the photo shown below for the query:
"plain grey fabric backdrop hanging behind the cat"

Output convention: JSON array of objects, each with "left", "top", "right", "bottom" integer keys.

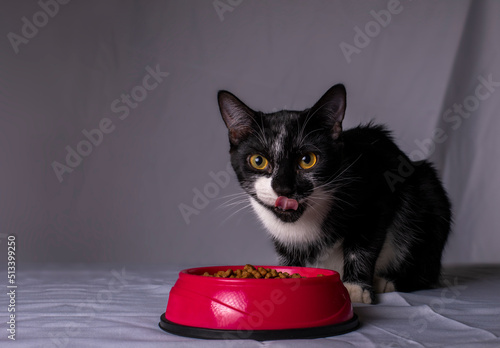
[{"left": 0, "top": 0, "right": 500, "bottom": 265}]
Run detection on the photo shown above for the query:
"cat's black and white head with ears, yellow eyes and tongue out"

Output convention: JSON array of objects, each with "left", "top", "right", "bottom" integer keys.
[{"left": 219, "top": 85, "right": 345, "bottom": 222}]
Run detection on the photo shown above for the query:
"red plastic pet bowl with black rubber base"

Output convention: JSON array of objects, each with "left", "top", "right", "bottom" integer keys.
[{"left": 159, "top": 266, "right": 359, "bottom": 341}]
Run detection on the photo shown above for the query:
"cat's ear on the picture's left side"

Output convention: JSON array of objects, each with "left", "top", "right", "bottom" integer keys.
[{"left": 217, "top": 91, "right": 255, "bottom": 145}]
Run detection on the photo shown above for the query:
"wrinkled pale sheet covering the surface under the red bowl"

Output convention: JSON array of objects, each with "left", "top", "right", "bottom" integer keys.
[{"left": 7, "top": 265, "right": 500, "bottom": 347}]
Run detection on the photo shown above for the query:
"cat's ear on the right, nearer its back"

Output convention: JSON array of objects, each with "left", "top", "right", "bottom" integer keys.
[{"left": 311, "top": 84, "right": 346, "bottom": 140}]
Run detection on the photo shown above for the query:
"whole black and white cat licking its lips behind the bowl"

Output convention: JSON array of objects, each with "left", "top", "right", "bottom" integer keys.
[{"left": 218, "top": 85, "right": 451, "bottom": 303}]
